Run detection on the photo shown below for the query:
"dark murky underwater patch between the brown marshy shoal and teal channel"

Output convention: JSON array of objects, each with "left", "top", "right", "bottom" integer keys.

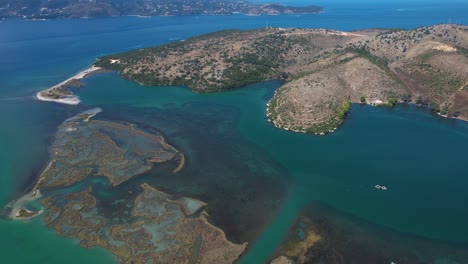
[{"left": 65, "top": 104, "right": 287, "bottom": 243}]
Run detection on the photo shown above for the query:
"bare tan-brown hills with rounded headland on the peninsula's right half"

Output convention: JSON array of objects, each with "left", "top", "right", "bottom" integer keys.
[{"left": 269, "top": 25, "right": 468, "bottom": 134}]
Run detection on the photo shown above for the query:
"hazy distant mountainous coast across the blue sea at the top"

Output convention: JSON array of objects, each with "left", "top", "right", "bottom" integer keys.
[{"left": 0, "top": 0, "right": 323, "bottom": 19}]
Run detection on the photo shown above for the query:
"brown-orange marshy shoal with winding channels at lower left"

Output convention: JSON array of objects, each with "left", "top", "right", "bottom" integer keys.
[{"left": 17, "top": 109, "right": 247, "bottom": 263}]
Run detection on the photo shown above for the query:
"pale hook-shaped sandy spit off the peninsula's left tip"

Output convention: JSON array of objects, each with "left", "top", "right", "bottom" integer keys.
[{"left": 36, "top": 65, "right": 103, "bottom": 105}]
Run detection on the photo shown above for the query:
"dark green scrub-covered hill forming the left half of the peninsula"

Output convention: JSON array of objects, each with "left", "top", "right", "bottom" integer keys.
[{"left": 95, "top": 28, "right": 366, "bottom": 92}]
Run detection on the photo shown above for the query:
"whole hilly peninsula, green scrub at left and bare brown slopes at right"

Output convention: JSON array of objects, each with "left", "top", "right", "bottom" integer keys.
[{"left": 96, "top": 25, "right": 468, "bottom": 134}]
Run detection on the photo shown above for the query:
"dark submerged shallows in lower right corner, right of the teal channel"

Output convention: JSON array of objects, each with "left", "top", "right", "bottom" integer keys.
[{"left": 276, "top": 202, "right": 468, "bottom": 264}]
